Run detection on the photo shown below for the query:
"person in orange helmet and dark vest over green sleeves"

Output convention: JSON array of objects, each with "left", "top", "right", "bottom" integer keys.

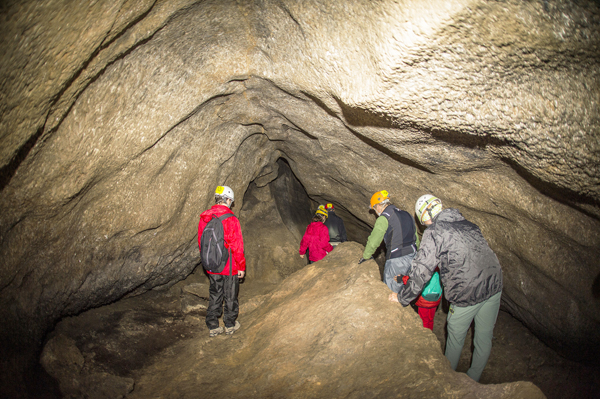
[{"left": 358, "top": 190, "right": 417, "bottom": 292}]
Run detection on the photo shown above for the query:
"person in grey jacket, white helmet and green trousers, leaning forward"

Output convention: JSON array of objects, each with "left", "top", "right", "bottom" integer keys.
[{"left": 390, "top": 194, "right": 502, "bottom": 381}]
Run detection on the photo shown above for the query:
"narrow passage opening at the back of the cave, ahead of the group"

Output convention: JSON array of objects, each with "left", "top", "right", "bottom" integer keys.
[{"left": 239, "top": 157, "right": 384, "bottom": 283}]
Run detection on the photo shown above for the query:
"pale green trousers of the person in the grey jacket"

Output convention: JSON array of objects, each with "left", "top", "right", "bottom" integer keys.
[{"left": 445, "top": 292, "right": 502, "bottom": 381}]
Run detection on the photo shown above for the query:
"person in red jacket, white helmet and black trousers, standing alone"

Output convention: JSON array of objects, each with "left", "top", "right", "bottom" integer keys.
[{"left": 198, "top": 186, "right": 246, "bottom": 337}]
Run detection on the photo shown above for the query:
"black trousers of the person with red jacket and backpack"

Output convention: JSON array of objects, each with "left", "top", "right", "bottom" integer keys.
[{"left": 206, "top": 273, "right": 240, "bottom": 330}]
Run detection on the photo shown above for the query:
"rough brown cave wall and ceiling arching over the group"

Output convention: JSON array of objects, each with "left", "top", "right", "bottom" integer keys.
[{"left": 0, "top": 0, "right": 600, "bottom": 390}]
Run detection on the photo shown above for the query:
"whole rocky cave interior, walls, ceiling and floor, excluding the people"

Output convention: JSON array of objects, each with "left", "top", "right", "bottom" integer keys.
[{"left": 0, "top": 0, "right": 600, "bottom": 398}]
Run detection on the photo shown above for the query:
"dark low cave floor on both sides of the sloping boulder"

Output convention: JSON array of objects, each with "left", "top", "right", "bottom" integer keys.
[{"left": 44, "top": 275, "right": 600, "bottom": 399}]
